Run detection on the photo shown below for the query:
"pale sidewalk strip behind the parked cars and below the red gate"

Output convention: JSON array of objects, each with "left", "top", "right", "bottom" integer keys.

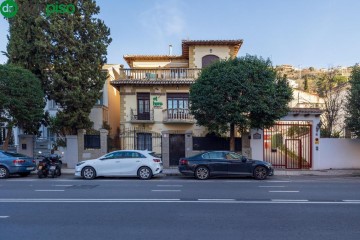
[{"left": 61, "top": 168, "right": 360, "bottom": 177}]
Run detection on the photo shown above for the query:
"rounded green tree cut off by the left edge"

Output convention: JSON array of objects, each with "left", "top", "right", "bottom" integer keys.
[{"left": 0, "top": 65, "right": 45, "bottom": 150}]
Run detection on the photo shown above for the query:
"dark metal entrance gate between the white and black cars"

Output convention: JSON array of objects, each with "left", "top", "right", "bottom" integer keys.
[{"left": 169, "top": 134, "right": 185, "bottom": 166}]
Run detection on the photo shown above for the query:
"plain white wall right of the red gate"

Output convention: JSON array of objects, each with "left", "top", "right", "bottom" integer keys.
[{"left": 314, "top": 138, "right": 360, "bottom": 169}]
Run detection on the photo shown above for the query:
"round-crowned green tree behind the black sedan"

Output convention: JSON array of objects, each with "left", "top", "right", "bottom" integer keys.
[{"left": 189, "top": 55, "right": 292, "bottom": 150}]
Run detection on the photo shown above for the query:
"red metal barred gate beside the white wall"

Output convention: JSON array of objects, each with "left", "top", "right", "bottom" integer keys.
[{"left": 264, "top": 121, "right": 312, "bottom": 169}]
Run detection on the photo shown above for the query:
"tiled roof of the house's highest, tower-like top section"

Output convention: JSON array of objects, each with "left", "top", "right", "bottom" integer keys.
[{"left": 182, "top": 39, "right": 243, "bottom": 58}]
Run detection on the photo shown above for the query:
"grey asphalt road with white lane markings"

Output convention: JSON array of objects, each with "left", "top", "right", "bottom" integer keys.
[{"left": 0, "top": 175, "right": 360, "bottom": 240}]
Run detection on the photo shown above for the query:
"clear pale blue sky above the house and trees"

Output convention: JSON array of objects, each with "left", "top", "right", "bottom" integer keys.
[{"left": 0, "top": 0, "right": 360, "bottom": 68}]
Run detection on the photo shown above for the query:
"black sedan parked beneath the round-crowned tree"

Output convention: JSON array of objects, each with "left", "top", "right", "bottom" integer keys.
[{"left": 179, "top": 151, "right": 274, "bottom": 180}]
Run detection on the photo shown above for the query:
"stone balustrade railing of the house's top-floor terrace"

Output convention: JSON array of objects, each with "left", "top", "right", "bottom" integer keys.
[{"left": 120, "top": 68, "right": 201, "bottom": 80}]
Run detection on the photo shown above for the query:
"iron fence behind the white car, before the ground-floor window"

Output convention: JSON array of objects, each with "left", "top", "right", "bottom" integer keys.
[{"left": 120, "top": 128, "right": 162, "bottom": 154}]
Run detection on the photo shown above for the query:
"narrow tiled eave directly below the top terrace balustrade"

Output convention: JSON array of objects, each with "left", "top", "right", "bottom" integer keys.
[{"left": 111, "top": 79, "right": 195, "bottom": 86}]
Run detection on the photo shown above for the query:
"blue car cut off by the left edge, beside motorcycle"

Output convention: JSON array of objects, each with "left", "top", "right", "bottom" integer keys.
[{"left": 0, "top": 151, "right": 36, "bottom": 179}]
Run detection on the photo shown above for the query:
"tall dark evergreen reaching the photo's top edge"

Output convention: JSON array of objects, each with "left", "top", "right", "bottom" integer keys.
[{"left": 7, "top": 0, "right": 111, "bottom": 134}]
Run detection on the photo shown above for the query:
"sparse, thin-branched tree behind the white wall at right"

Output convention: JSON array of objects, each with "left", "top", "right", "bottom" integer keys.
[{"left": 316, "top": 71, "right": 347, "bottom": 138}]
